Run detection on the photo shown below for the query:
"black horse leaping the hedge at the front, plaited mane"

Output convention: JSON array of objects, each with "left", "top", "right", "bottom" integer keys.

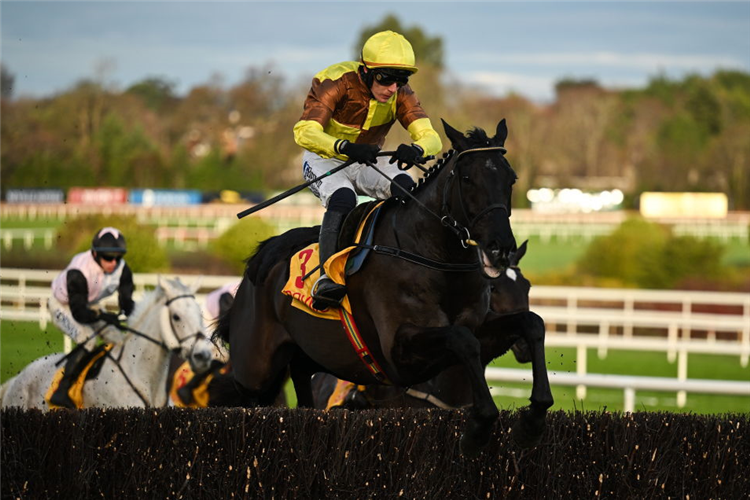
[{"left": 216, "top": 120, "right": 532, "bottom": 456}]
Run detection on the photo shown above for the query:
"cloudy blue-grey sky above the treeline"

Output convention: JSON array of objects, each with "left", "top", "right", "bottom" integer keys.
[{"left": 0, "top": 0, "right": 750, "bottom": 101}]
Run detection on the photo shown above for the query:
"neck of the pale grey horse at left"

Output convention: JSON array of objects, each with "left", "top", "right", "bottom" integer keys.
[{"left": 115, "top": 305, "right": 169, "bottom": 406}]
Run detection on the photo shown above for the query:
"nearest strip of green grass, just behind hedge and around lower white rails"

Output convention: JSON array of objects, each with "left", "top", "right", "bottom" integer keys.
[{"left": 0, "top": 321, "right": 750, "bottom": 414}]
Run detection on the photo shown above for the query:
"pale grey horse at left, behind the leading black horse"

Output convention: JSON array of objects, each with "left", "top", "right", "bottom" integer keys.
[{"left": 0, "top": 278, "right": 216, "bottom": 410}]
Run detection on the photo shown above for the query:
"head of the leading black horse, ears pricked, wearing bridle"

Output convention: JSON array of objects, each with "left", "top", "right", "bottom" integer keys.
[{"left": 443, "top": 119, "right": 516, "bottom": 278}]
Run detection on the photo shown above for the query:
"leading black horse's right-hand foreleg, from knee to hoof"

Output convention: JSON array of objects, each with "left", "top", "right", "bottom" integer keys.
[{"left": 513, "top": 312, "right": 554, "bottom": 448}]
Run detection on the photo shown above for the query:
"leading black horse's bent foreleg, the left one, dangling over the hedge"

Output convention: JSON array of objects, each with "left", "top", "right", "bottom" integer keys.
[{"left": 394, "top": 326, "right": 499, "bottom": 457}]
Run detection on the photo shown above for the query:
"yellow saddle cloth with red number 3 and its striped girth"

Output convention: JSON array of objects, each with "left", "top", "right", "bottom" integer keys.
[{"left": 281, "top": 201, "right": 388, "bottom": 383}]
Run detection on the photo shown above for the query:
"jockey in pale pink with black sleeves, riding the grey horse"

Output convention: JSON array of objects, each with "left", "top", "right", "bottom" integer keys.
[{"left": 47, "top": 227, "right": 134, "bottom": 408}]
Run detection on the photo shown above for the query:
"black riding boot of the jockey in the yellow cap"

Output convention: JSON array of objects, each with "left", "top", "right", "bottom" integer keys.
[{"left": 312, "top": 188, "right": 357, "bottom": 309}]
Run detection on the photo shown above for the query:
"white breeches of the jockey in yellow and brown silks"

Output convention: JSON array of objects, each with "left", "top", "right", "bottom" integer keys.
[{"left": 302, "top": 151, "right": 409, "bottom": 208}]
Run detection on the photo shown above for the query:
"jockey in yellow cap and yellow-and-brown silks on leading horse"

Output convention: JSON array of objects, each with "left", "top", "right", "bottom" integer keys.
[{"left": 294, "top": 31, "right": 442, "bottom": 309}]
